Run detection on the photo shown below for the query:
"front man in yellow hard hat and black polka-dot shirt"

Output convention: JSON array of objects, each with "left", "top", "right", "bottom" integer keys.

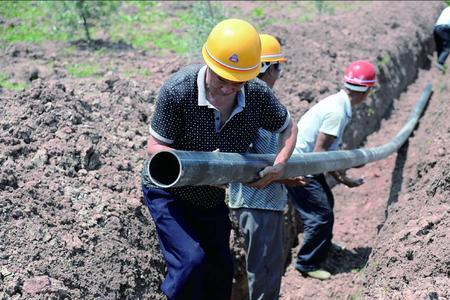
[{"left": 142, "top": 19, "right": 297, "bottom": 300}]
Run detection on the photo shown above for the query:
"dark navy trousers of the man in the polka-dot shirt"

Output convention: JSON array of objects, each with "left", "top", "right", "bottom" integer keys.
[{"left": 142, "top": 187, "right": 233, "bottom": 300}]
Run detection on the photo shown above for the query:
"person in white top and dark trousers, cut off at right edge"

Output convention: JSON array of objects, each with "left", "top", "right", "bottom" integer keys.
[{"left": 433, "top": 6, "right": 450, "bottom": 73}]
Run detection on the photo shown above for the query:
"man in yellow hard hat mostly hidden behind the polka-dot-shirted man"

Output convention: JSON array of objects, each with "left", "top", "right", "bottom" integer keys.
[{"left": 228, "top": 34, "right": 288, "bottom": 300}]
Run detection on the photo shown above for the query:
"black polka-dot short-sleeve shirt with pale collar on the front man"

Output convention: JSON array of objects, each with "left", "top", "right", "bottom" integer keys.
[{"left": 143, "top": 65, "right": 290, "bottom": 208}]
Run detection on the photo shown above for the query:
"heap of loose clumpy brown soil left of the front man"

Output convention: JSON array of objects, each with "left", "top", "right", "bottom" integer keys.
[{"left": 0, "top": 78, "right": 164, "bottom": 299}]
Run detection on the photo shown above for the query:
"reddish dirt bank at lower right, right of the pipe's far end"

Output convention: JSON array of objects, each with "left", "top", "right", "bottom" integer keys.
[{"left": 362, "top": 70, "right": 450, "bottom": 299}]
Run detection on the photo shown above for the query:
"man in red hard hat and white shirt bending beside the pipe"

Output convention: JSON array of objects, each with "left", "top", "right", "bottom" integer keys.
[{"left": 287, "top": 61, "right": 376, "bottom": 280}]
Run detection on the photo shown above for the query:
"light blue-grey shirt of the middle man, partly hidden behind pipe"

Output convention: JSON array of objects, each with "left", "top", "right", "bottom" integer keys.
[{"left": 228, "top": 129, "right": 287, "bottom": 211}]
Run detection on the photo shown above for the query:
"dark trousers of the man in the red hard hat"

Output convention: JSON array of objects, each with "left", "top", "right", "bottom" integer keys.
[{"left": 287, "top": 174, "right": 334, "bottom": 272}]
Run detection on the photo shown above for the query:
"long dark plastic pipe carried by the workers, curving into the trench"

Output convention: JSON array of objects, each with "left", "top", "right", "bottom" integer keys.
[{"left": 144, "top": 83, "right": 432, "bottom": 188}]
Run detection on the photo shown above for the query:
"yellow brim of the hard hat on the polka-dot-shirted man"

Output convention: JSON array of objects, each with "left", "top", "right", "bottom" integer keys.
[{"left": 202, "top": 44, "right": 261, "bottom": 82}]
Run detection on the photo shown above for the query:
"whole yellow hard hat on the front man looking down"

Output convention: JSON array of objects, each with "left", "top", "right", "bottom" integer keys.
[{"left": 202, "top": 19, "right": 261, "bottom": 82}]
